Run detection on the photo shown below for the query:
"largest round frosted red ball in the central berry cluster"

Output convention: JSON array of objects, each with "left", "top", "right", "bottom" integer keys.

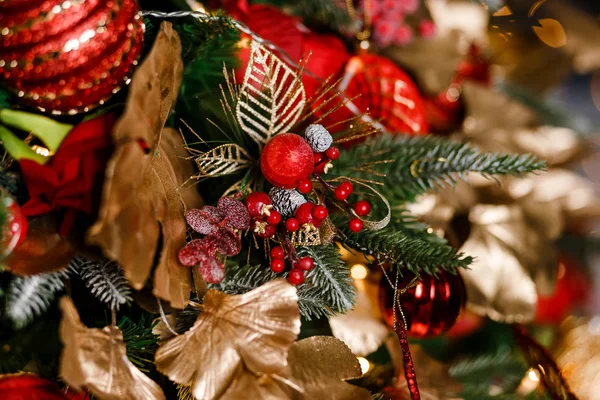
[{"left": 260, "top": 133, "right": 314, "bottom": 189}]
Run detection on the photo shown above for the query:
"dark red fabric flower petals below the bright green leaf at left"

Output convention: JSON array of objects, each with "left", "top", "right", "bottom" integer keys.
[{"left": 20, "top": 113, "right": 115, "bottom": 235}]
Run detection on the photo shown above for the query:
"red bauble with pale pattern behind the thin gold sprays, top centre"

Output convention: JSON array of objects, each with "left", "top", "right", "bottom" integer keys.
[{"left": 317, "top": 54, "right": 429, "bottom": 135}]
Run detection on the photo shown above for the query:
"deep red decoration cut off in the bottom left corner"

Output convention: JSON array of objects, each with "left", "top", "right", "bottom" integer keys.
[{"left": 0, "top": 374, "right": 89, "bottom": 400}]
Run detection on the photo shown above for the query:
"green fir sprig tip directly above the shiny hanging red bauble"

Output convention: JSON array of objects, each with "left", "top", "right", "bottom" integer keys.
[{"left": 340, "top": 228, "right": 473, "bottom": 275}]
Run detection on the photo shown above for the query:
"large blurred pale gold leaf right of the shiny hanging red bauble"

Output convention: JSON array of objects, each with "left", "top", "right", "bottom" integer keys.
[{"left": 461, "top": 204, "right": 557, "bottom": 322}]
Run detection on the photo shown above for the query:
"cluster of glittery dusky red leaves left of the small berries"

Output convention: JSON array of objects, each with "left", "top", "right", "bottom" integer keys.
[{"left": 179, "top": 197, "right": 250, "bottom": 283}]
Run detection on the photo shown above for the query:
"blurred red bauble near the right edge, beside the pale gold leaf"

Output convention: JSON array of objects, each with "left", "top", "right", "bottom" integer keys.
[{"left": 535, "top": 256, "right": 592, "bottom": 325}]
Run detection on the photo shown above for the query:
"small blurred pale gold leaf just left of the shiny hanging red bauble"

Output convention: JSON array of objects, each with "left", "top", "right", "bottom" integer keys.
[{"left": 329, "top": 276, "right": 389, "bottom": 356}]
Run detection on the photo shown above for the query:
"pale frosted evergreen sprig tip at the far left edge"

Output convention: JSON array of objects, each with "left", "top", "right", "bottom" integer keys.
[{"left": 6, "top": 271, "right": 68, "bottom": 329}]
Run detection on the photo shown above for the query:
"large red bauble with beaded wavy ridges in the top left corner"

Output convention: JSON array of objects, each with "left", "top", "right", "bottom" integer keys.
[{"left": 0, "top": 0, "right": 144, "bottom": 114}]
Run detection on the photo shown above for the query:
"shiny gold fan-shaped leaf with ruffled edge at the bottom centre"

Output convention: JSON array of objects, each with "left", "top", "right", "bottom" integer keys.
[{"left": 155, "top": 279, "right": 300, "bottom": 399}]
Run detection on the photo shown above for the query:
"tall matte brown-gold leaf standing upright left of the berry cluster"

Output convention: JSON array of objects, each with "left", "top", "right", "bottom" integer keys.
[{"left": 87, "top": 22, "right": 201, "bottom": 308}]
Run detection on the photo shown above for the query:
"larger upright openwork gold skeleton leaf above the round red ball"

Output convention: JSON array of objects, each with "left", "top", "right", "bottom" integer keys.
[{"left": 235, "top": 41, "right": 306, "bottom": 145}]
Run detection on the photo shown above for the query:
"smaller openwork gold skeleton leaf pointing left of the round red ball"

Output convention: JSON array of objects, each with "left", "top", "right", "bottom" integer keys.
[{"left": 194, "top": 144, "right": 251, "bottom": 178}]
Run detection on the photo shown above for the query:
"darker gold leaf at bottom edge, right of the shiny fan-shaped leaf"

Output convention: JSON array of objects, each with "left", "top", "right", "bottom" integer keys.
[{"left": 220, "top": 336, "right": 371, "bottom": 400}]
